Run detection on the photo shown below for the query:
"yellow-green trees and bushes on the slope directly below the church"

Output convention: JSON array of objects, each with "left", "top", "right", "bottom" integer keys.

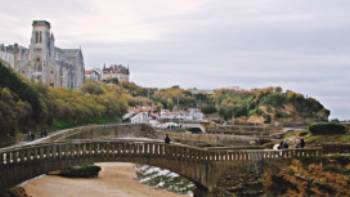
[{"left": 0, "top": 63, "right": 131, "bottom": 146}]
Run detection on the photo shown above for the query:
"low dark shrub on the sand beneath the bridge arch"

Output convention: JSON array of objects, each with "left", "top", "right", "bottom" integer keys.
[{"left": 59, "top": 165, "right": 101, "bottom": 178}]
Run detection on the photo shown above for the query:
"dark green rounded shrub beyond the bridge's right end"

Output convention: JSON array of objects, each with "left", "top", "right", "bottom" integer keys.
[{"left": 309, "top": 123, "right": 347, "bottom": 135}]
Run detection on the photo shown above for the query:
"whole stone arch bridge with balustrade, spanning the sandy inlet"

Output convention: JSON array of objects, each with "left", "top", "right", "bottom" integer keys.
[{"left": 0, "top": 140, "right": 322, "bottom": 196}]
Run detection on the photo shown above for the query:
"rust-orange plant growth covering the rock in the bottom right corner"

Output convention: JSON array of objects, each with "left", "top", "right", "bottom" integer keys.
[{"left": 263, "top": 160, "right": 350, "bottom": 196}]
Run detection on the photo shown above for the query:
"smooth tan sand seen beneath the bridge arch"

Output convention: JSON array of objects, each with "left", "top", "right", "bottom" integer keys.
[{"left": 23, "top": 163, "right": 189, "bottom": 197}]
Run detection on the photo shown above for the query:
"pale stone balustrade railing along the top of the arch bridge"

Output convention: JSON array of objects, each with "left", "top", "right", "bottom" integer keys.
[{"left": 0, "top": 140, "right": 322, "bottom": 165}]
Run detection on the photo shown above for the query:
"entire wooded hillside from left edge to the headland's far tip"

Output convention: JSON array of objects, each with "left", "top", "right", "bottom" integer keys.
[{"left": 0, "top": 62, "right": 330, "bottom": 146}]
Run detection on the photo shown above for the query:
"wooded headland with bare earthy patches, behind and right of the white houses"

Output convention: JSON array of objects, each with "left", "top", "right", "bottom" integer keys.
[{"left": 122, "top": 83, "right": 330, "bottom": 123}]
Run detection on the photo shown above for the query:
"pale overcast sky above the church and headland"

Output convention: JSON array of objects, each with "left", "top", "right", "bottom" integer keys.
[{"left": 0, "top": 0, "right": 350, "bottom": 119}]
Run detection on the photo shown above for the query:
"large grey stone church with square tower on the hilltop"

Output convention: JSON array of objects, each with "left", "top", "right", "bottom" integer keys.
[{"left": 0, "top": 20, "right": 85, "bottom": 89}]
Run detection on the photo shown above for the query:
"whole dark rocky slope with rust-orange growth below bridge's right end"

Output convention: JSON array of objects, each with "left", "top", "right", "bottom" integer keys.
[{"left": 215, "top": 157, "right": 350, "bottom": 197}]
